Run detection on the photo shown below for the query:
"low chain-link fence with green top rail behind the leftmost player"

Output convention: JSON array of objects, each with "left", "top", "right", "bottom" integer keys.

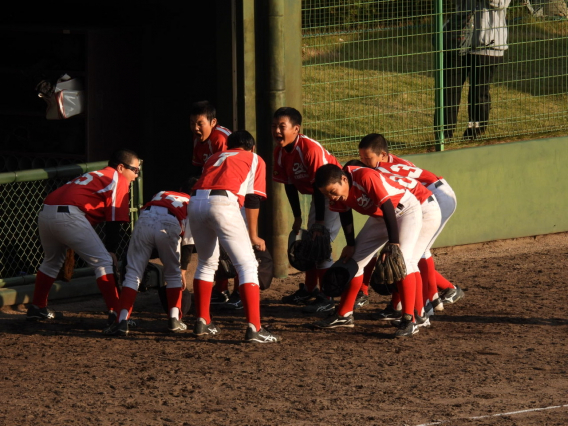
[{"left": 0, "top": 161, "right": 142, "bottom": 279}]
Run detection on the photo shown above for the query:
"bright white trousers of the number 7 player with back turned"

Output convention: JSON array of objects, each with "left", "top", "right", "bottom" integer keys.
[{"left": 188, "top": 191, "right": 258, "bottom": 285}]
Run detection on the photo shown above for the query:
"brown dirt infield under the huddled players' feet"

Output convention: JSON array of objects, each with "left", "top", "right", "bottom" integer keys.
[{"left": 0, "top": 234, "right": 568, "bottom": 426}]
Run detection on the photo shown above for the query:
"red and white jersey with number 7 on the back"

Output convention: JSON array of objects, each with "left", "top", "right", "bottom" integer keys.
[{"left": 193, "top": 149, "right": 266, "bottom": 206}]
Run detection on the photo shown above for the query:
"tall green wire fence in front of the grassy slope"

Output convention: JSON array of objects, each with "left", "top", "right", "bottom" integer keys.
[{"left": 302, "top": 0, "right": 568, "bottom": 157}]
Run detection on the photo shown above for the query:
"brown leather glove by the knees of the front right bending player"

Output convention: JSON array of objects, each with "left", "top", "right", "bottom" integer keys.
[{"left": 371, "top": 243, "right": 406, "bottom": 296}]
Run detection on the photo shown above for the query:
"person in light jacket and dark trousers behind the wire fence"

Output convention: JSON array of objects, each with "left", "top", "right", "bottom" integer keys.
[{"left": 435, "top": 0, "right": 511, "bottom": 139}]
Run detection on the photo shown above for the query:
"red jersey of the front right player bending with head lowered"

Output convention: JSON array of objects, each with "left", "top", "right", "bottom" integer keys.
[{"left": 329, "top": 166, "right": 406, "bottom": 217}]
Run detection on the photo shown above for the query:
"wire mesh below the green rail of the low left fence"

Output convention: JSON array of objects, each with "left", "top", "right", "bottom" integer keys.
[{"left": 0, "top": 170, "right": 132, "bottom": 278}]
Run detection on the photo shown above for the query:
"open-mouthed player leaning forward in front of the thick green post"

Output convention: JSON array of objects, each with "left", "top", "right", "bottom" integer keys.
[{"left": 272, "top": 107, "right": 341, "bottom": 312}]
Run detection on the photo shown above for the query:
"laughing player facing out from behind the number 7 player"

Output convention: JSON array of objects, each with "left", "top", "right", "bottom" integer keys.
[{"left": 189, "top": 101, "right": 231, "bottom": 304}]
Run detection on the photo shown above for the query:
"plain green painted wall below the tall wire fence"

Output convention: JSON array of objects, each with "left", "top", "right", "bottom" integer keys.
[{"left": 296, "top": 137, "right": 568, "bottom": 255}]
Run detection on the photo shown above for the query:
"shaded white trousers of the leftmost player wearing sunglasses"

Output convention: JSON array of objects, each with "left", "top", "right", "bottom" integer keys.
[{"left": 40, "top": 205, "right": 112, "bottom": 278}]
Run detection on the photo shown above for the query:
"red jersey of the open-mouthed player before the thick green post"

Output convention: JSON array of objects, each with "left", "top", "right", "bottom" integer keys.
[{"left": 272, "top": 135, "right": 341, "bottom": 194}]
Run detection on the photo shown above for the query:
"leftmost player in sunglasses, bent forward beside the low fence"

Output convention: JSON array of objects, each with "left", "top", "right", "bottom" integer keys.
[{"left": 27, "top": 149, "right": 140, "bottom": 323}]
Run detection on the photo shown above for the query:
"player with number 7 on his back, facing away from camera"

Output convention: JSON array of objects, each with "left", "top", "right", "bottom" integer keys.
[{"left": 188, "top": 130, "right": 280, "bottom": 343}]
